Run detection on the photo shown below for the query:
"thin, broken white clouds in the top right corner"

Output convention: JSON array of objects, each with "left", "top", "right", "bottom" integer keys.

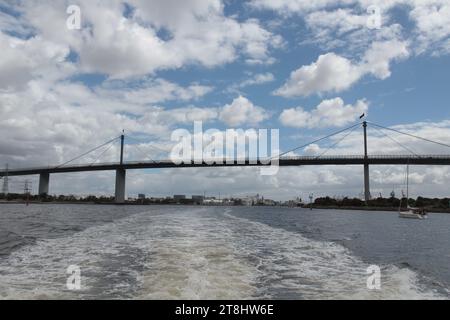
[{"left": 250, "top": 0, "right": 450, "bottom": 55}]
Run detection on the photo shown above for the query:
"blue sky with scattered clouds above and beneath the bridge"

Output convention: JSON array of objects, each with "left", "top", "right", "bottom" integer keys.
[{"left": 0, "top": 0, "right": 450, "bottom": 199}]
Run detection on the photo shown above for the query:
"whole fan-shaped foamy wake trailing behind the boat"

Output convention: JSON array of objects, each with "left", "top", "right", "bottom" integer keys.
[{"left": 0, "top": 207, "right": 445, "bottom": 299}]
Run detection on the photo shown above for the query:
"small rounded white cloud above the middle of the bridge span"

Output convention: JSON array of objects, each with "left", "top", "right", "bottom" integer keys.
[{"left": 219, "top": 96, "right": 269, "bottom": 127}]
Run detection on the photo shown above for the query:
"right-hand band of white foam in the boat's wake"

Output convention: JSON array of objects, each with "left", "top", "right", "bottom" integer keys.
[{"left": 220, "top": 214, "right": 443, "bottom": 299}]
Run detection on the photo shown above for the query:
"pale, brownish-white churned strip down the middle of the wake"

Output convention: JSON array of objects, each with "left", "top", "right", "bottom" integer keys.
[{"left": 135, "top": 215, "right": 257, "bottom": 299}]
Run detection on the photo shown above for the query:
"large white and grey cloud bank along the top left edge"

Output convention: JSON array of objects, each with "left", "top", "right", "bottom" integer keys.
[{"left": 11, "top": 0, "right": 282, "bottom": 78}]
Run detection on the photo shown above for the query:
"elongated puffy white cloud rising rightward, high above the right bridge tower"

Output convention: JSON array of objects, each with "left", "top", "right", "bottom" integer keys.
[{"left": 274, "top": 40, "right": 408, "bottom": 97}]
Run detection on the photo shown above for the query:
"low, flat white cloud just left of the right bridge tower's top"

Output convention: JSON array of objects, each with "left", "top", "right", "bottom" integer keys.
[{"left": 280, "top": 98, "right": 368, "bottom": 128}]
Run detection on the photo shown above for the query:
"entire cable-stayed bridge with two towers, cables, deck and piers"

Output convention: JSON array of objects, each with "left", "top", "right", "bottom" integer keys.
[{"left": 0, "top": 121, "right": 450, "bottom": 204}]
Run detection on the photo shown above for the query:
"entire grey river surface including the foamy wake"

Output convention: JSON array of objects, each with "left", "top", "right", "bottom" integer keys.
[{"left": 0, "top": 204, "right": 450, "bottom": 299}]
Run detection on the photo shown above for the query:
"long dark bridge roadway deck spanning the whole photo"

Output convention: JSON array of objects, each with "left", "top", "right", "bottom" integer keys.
[{"left": 0, "top": 155, "right": 450, "bottom": 177}]
